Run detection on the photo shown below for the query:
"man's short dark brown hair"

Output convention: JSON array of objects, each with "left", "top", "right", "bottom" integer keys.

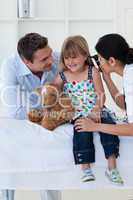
[{"left": 17, "top": 33, "right": 48, "bottom": 62}]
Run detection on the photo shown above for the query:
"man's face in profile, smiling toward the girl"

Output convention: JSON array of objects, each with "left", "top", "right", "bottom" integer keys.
[{"left": 24, "top": 47, "right": 53, "bottom": 73}]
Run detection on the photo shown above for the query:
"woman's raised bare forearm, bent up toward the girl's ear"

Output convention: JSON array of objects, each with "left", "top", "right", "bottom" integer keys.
[{"left": 102, "top": 72, "right": 125, "bottom": 110}]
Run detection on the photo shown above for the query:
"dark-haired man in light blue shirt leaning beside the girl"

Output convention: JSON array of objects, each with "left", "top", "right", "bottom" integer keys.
[{"left": 0, "top": 33, "right": 60, "bottom": 200}]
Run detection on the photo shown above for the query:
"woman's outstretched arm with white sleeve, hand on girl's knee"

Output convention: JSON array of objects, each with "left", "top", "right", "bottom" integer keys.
[{"left": 75, "top": 65, "right": 133, "bottom": 136}]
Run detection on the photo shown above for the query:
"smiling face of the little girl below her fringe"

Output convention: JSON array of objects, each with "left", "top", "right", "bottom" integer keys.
[{"left": 64, "top": 54, "right": 87, "bottom": 72}]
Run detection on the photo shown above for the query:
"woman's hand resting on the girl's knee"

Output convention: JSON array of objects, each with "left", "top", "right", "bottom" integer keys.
[{"left": 74, "top": 118, "right": 97, "bottom": 132}]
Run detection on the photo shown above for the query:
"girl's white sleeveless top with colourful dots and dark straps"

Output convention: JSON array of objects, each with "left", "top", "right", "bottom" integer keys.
[{"left": 60, "top": 67, "right": 96, "bottom": 119}]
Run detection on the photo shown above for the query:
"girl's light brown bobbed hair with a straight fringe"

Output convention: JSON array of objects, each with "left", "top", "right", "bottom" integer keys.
[{"left": 60, "top": 35, "right": 90, "bottom": 70}]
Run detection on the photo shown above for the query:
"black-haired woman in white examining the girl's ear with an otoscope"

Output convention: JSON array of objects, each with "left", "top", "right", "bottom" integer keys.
[{"left": 75, "top": 33, "right": 133, "bottom": 136}]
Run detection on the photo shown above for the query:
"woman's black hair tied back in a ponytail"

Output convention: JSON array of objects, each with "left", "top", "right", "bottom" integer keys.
[{"left": 95, "top": 33, "right": 133, "bottom": 65}]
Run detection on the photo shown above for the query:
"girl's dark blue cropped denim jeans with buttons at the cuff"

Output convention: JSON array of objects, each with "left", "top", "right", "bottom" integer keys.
[{"left": 73, "top": 109, "right": 119, "bottom": 164}]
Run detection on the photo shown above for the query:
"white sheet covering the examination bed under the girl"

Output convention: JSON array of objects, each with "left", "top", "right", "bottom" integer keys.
[{"left": 0, "top": 118, "right": 133, "bottom": 189}]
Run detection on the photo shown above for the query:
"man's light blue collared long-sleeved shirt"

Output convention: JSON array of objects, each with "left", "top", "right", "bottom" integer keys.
[{"left": 0, "top": 52, "right": 59, "bottom": 119}]
